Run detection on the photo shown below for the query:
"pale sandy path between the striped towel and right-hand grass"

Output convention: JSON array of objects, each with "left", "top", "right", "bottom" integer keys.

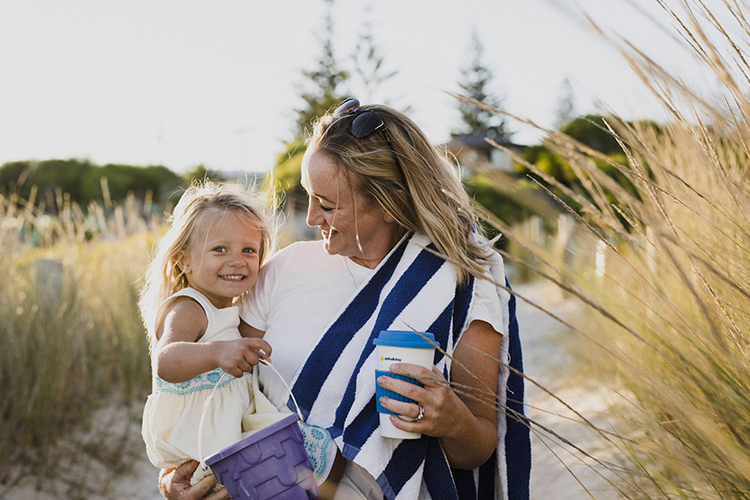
[{"left": 515, "top": 284, "right": 619, "bottom": 500}]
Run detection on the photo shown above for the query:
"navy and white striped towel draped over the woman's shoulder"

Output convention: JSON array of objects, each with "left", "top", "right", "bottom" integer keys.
[{"left": 289, "top": 234, "right": 531, "bottom": 500}]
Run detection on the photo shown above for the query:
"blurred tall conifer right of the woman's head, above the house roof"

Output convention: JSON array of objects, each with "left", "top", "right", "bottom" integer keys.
[{"left": 455, "top": 31, "right": 511, "bottom": 139}]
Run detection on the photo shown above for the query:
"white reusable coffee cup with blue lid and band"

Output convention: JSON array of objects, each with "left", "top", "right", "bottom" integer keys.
[{"left": 372, "top": 330, "right": 435, "bottom": 439}]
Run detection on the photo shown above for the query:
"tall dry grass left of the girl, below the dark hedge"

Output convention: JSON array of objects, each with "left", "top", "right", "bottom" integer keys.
[{"left": 0, "top": 189, "right": 159, "bottom": 492}]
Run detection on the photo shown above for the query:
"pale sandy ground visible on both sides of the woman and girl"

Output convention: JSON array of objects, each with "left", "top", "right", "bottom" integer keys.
[{"left": 0, "top": 285, "right": 616, "bottom": 500}]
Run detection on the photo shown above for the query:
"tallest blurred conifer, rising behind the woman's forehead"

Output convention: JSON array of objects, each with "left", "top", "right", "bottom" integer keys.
[{"left": 294, "top": 0, "right": 349, "bottom": 139}]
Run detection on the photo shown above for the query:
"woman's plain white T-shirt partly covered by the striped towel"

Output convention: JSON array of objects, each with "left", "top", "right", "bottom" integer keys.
[{"left": 240, "top": 240, "right": 507, "bottom": 500}]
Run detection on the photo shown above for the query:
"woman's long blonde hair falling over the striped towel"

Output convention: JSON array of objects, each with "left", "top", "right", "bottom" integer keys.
[{"left": 307, "top": 105, "right": 489, "bottom": 282}]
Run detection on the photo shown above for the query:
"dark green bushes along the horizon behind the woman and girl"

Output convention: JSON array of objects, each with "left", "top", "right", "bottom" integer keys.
[{"left": 0, "top": 111, "right": 631, "bottom": 234}]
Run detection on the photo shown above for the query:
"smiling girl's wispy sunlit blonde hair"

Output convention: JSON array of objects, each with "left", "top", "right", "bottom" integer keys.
[{"left": 138, "top": 180, "right": 273, "bottom": 340}]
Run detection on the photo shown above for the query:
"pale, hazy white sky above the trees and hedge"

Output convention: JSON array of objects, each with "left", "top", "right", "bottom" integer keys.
[{"left": 0, "top": 0, "right": 720, "bottom": 176}]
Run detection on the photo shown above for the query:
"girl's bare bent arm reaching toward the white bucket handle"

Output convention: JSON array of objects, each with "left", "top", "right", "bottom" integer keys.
[{"left": 156, "top": 298, "right": 271, "bottom": 384}]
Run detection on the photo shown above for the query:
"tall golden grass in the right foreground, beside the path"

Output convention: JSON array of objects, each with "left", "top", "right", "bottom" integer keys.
[{"left": 476, "top": 1, "right": 750, "bottom": 499}]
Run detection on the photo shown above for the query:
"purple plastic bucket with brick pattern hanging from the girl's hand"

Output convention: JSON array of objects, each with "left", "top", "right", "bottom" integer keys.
[{"left": 206, "top": 413, "right": 319, "bottom": 500}]
